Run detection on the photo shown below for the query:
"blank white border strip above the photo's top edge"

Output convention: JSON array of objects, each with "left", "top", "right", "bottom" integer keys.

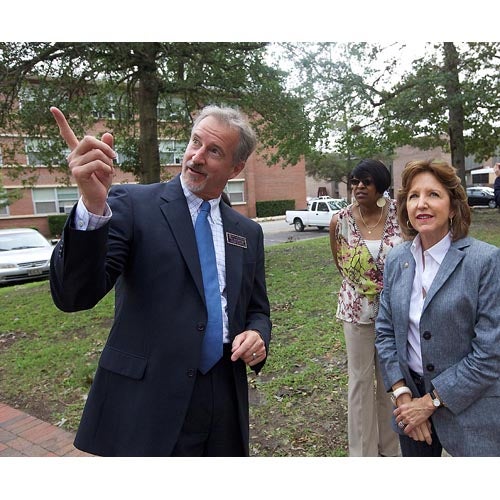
[{"left": 0, "top": 0, "right": 500, "bottom": 41}]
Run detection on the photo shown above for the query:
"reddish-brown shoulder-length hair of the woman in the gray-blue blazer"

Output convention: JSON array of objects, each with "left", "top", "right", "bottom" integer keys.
[{"left": 397, "top": 160, "right": 471, "bottom": 241}]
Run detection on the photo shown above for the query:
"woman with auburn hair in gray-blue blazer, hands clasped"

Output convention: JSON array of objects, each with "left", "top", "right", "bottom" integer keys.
[{"left": 376, "top": 161, "right": 500, "bottom": 456}]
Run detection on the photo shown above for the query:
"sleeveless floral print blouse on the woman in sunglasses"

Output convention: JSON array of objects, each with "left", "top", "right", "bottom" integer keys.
[{"left": 335, "top": 200, "right": 403, "bottom": 324}]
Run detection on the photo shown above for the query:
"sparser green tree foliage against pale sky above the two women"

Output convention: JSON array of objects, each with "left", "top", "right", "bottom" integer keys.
[{"left": 285, "top": 42, "right": 500, "bottom": 182}]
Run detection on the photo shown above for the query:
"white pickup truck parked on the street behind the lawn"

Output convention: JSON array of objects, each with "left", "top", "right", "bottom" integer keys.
[{"left": 285, "top": 196, "right": 347, "bottom": 232}]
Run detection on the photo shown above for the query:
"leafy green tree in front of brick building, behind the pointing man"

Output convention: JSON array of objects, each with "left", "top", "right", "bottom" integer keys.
[{"left": 0, "top": 42, "right": 311, "bottom": 183}]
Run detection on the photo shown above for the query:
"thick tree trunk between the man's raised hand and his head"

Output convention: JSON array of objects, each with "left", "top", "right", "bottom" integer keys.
[{"left": 138, "top": 68, "right": 160, "bottom": 184}]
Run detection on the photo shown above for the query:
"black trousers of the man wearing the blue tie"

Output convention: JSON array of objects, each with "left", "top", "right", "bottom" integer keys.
[{"left": 172, "top": 345, "right": 244, "bottom": 457}]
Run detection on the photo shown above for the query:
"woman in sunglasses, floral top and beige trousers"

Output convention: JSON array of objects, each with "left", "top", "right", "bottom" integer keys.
[{"left": 330, "top": 159, "right": 402, "bottom": 457}]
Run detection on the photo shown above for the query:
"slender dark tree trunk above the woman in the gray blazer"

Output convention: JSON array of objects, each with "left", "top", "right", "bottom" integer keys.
[{"left": 444, "top": 42, "right": 466, "bottom": 187}]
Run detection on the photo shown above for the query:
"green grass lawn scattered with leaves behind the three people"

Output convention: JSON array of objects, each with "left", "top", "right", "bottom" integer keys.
[{"left": 0, "top": 209, "right": 500, "bottom": 456}]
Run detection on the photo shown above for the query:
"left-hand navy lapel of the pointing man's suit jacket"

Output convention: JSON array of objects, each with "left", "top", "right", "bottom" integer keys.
[{"left": 160, "top": 176, "right": 205, "bottom": 298}]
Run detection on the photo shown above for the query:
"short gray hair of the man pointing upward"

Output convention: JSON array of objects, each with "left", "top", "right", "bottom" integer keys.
[{"left": 193, "top": 105, "right": 257, "bottom": 164}]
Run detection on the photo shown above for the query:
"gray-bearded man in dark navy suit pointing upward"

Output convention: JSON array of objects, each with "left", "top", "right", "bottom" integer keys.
[{"left": 50, "top": 106, "right": 271, "bottom": 456}]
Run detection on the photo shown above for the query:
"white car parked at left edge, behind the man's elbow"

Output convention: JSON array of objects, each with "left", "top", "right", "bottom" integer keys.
[{"left": 0, "top": 228, "right": 54, "bottom": 284}]
